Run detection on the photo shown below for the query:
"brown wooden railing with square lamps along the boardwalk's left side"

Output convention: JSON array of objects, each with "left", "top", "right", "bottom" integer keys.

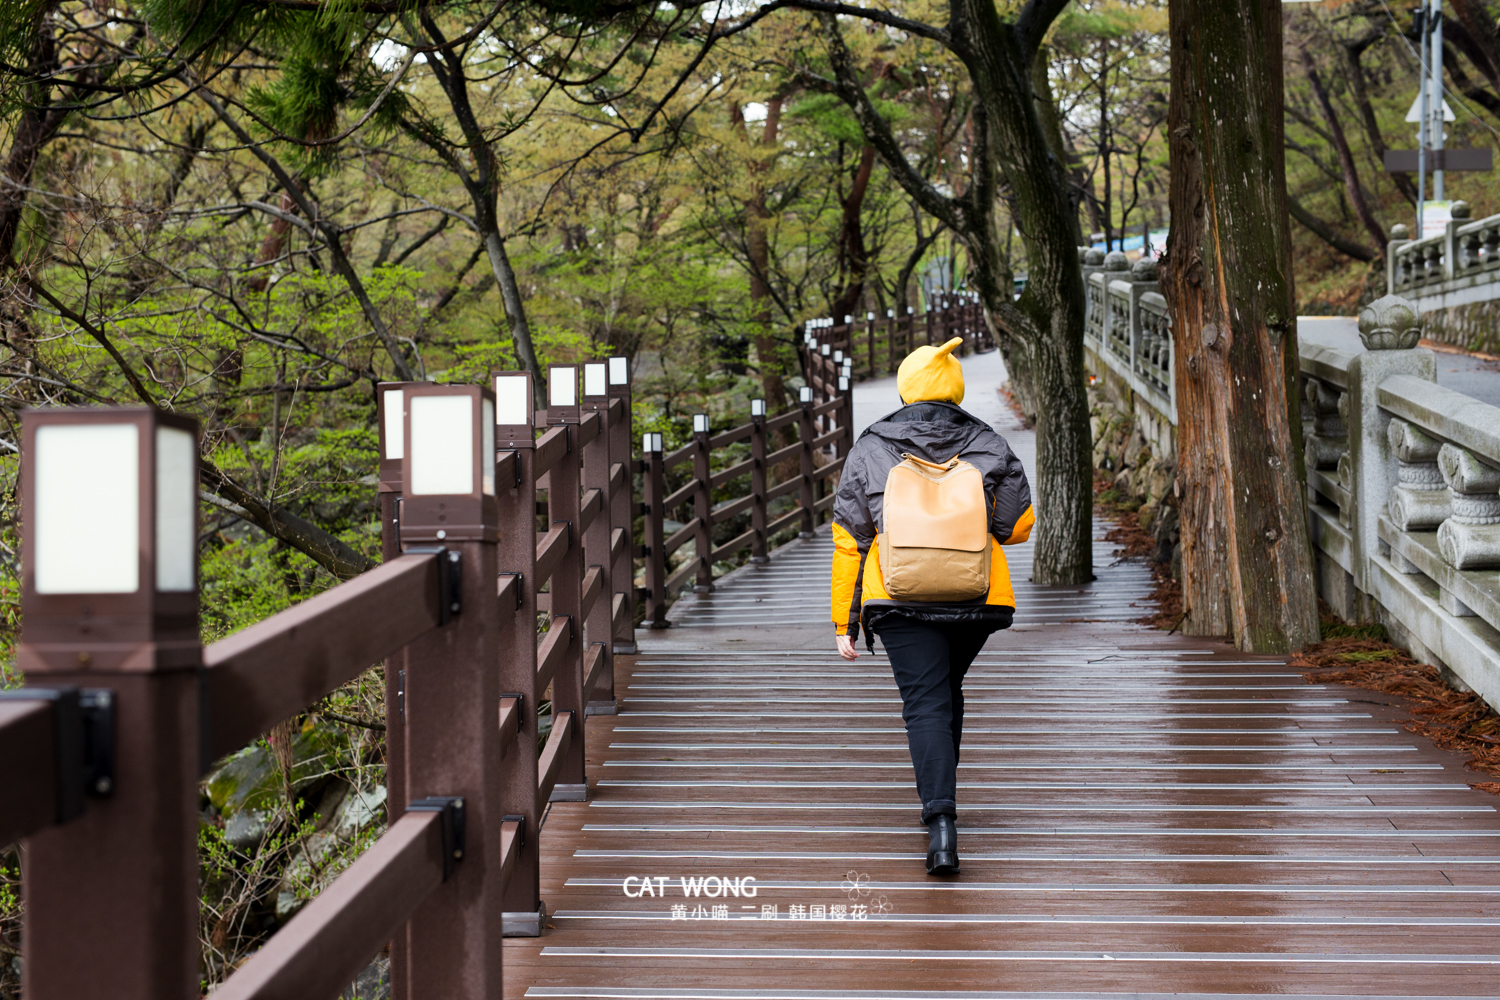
[{"left": 0, "top": 358, "right": 849, "bottom": 1000}]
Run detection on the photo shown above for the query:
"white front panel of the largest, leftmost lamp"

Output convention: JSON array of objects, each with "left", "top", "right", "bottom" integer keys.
[{"left": 29, "top": 424, "right": 141, "bottom": 594}]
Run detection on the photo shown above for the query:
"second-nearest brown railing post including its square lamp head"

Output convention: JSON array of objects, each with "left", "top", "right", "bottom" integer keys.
[{"left": 401, "top": 385, "right": 504, "bottom": 1000}]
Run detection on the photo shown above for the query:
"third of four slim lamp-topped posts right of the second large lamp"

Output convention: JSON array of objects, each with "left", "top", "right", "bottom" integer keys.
[{"left": 584, "top": 361, "right": 615, "bottom": 715}]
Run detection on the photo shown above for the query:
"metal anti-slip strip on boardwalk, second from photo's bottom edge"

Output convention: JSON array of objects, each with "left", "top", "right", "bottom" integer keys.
[{"left": 542, "top": 945, "right": 1500, "bottom": 966}]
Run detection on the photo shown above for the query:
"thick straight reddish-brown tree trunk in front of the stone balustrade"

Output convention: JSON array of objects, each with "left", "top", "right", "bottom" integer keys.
[{"left": 1163, "top": 0, "right": 1319, "bottom": 652}]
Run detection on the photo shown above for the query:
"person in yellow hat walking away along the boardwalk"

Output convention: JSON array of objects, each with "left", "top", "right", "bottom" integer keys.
[{"left": 831, "top": 337, "right": 1035, "bottom": 874}]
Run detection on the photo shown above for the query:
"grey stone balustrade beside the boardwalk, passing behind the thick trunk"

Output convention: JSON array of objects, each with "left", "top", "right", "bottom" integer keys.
[{"left": 1083, "top": 262, "right": 1500, "bottom": 716}]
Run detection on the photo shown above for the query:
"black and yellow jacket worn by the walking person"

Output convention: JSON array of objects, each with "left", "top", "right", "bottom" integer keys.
[{"left": 831, "top": 402, "right": 1035, "bottom": 637}]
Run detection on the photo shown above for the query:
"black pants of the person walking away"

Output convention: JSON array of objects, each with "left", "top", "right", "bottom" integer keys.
[{"left": 875, "top": 615, "right": 995, "bottom": 823}]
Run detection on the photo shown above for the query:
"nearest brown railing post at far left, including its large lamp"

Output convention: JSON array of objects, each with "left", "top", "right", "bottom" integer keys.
[{"left": 17, "top": 408, "right": 207, "bottom": 1000}]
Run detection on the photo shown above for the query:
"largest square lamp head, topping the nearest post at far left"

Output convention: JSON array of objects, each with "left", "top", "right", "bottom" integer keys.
[{"left": 17, "top": 406, "right": 201, "bottom": 673}]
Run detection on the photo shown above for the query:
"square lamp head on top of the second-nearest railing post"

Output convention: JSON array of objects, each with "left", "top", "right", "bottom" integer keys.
[{"left": 401, "top": 384, "right": 500, "bottom": 547}]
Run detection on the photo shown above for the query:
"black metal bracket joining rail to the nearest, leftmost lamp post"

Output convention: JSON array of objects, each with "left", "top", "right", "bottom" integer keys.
[{"left": 0, "top": 687, "right": 114, "bottom": 823}]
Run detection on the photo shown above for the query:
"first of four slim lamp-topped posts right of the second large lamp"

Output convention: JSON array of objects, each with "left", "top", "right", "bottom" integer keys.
[{"left": 492, "top": 372, "right": 546, "bottom": 935}]
